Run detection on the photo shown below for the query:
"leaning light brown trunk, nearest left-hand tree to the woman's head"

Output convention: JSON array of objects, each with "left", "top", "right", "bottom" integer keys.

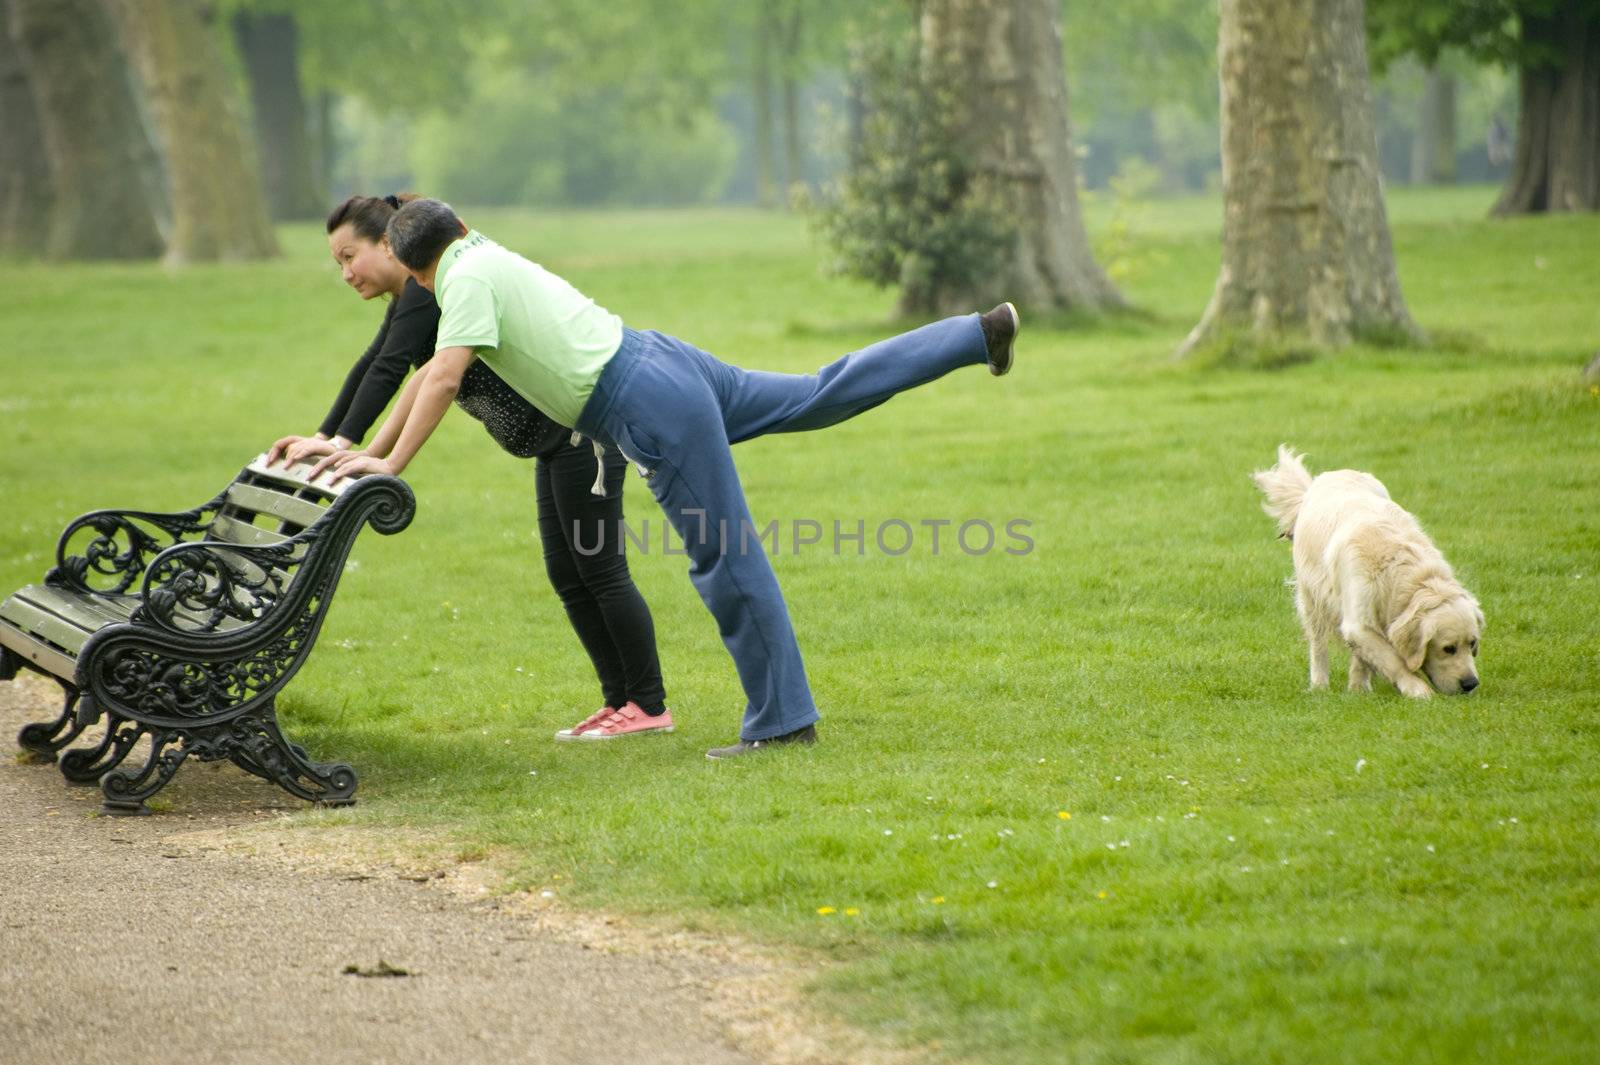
[{"left": 110, "top": 0, "right": 278, "bottom": 262}]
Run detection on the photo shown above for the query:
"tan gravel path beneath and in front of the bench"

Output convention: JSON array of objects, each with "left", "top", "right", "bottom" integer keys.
[{"left": 0, "top": 676, "right": 888, "bottom": 1065}]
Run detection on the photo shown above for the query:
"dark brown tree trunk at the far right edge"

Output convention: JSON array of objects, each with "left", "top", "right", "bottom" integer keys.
[{"left": 1494, "top": 0, "right": 1600, "bottom": 214}]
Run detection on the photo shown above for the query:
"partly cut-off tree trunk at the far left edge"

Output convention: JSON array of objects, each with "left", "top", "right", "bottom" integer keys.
[{"left": 0, "top": 2, "right": 51, "bottom": 254}]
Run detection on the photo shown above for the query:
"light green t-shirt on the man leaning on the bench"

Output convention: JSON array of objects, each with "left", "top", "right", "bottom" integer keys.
[{"left": 434, "top": 230, "right": 622, "bottom": 425}]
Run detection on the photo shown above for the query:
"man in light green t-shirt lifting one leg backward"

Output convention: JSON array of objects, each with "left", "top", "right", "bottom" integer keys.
[{"left": 323, "top": 200, "right": 1019, "bottom": 760}]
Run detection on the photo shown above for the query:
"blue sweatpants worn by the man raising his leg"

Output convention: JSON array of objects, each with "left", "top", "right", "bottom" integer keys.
[{"left": 574, "top": 315, "right": 987, "bottom": 740}]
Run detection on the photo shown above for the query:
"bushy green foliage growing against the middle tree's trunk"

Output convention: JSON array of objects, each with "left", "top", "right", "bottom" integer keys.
[{"left": 806, "top": 13, "right": 1014, "bottom": 312}]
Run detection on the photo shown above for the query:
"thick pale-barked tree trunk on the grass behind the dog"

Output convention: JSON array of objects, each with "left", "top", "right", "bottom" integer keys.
[{"left": 1179, "top": 0, "right": 1421, "bottom": 355}]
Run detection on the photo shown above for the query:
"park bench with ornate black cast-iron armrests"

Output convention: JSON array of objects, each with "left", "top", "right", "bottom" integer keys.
[{"left": 0, "top": 456, "right": 416, "bottom": 814}]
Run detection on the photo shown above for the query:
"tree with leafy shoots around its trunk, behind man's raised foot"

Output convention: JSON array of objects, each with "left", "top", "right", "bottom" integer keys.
[{"left": 816, "top": 0, "right": 1122, "bottom": 317}]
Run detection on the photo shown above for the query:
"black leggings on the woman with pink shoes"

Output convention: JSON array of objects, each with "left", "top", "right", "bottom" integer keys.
[{"left": 534, "top": 441, "right": 667, "bottom": 710}]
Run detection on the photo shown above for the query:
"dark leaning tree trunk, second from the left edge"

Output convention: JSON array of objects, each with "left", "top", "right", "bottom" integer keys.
[{"left": 5, "top": 0, "right": 165, "bottom": 259}]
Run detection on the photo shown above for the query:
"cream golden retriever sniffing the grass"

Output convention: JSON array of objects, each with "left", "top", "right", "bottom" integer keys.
[{"left": 1251, "top": 445, "right": 1483, "bottom": 699}]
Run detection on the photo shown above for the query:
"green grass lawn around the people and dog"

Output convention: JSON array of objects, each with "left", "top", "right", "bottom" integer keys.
[{"left": 0, "top": 189, "right": 1600, "bottom": 1063}]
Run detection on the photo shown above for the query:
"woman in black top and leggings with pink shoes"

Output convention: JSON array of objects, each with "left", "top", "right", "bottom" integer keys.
[{"left": 267, "top": 197, "right": 672, "bottom": 739}]
